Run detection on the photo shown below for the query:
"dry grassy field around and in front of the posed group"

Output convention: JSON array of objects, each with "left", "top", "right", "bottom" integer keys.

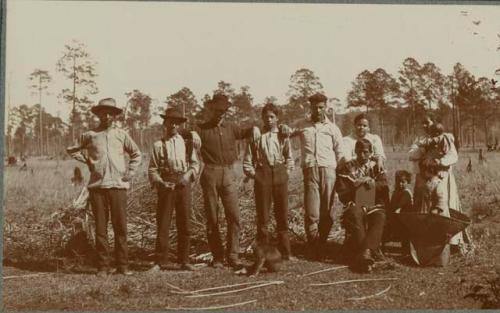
[{"left": 3, "top": 152, "right": 500, "bottom": 311}]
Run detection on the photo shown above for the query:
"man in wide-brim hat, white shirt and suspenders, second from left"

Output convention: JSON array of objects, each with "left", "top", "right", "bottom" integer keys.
[{"left": 148, "top": 108, "right": 200, "bottom": 271}]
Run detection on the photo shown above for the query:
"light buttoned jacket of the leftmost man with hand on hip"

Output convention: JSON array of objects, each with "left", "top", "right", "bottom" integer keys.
[{"left": 67, "top": 127, "right": 141, "bottom": 189}]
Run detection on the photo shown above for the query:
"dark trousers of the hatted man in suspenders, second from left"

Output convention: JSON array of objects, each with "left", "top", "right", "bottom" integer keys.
[{"left": 156, "top": 184, "right": 191, "bottom": 265}]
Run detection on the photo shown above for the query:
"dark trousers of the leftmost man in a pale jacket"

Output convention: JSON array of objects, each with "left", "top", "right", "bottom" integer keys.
[{"left": 89, "top": 188, "right": 128, "bottom": 269}]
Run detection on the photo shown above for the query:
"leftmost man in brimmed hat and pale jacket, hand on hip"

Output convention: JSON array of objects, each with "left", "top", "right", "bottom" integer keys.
[{"left": 67, "top": 98, "right": 141, "bottom": 276}]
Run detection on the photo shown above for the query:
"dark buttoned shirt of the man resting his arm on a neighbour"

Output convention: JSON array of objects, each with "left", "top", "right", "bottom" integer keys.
[{"left": 196, "top": 122, "right": 250, "bottom": 165}]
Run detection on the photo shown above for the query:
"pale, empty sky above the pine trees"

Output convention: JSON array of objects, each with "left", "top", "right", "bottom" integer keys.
[{"left": 6, "top": 0, "right": 500, "bottom": 118}]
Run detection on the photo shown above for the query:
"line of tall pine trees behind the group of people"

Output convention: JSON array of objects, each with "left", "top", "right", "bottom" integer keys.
[{"left": 6, "top": 41, "right": 500, "bottom": 156}]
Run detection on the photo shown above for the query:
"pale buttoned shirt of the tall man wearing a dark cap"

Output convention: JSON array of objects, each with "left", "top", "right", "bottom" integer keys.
[{"left": 293, "top": 120, "right": 345, "bottom": 168}]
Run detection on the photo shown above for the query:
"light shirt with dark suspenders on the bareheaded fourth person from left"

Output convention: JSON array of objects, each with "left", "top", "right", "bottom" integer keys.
[{"left": 243, "top": 130, "right": 294, "bottom": 174}]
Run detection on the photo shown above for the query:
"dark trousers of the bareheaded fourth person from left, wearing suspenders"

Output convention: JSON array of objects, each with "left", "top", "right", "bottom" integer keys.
[{"left": 254, "top": 166, "right": 290, "bottom": 258}]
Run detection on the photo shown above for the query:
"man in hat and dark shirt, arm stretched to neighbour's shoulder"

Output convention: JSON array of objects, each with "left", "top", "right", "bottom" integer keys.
[{"left": 191, "top": 94, "right": 260, "bottom": 269}]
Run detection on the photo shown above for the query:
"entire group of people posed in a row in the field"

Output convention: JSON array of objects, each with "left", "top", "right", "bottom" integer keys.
[{"left": 67, "top": 94, "right": 464, "bottom": 275}]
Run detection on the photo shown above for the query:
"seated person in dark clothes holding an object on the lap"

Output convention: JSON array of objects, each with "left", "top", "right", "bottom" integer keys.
[{"left": 337, "top": 139, "right": 389, "bottom": 272}]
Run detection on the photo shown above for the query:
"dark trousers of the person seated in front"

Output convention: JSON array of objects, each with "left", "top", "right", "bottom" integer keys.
[{"left": 343, "top": 205, "right": 385, "bottom": 254}]
